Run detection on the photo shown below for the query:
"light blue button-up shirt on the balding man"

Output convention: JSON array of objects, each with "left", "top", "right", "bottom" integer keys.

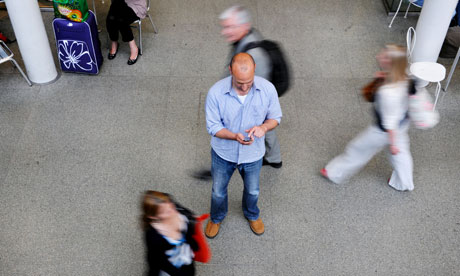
[{"left": 205, "top": 76, "right": 282, "bottom": 164}]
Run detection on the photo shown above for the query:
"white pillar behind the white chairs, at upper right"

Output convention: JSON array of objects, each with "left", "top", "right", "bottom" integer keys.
[{"left": 411, "top": 0, "right": 458, "bottom": 62}]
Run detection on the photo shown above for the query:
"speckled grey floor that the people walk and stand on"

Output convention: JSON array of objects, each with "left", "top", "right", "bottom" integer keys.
[{"left": 0, "top": 0, "right": 460, "bottom": 276}]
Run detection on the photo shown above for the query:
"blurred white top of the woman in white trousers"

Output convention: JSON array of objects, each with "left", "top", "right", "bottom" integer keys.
[{"left": 376, "top": 81, "right": 409, "bottom": 130}]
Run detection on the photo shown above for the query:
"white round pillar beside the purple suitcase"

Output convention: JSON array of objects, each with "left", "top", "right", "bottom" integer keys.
[{"left": 5, "top": 0, "right": 58, "bottom": 83}]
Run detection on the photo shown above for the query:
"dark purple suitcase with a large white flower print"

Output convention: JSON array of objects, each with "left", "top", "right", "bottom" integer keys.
[{"left": 53, "top": 11, "right": 103, "bottom": 74}]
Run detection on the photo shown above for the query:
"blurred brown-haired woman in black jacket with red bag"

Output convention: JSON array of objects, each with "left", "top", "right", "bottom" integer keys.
[{"left": 142, "top": 191, "right": 210, "bottom": 276}]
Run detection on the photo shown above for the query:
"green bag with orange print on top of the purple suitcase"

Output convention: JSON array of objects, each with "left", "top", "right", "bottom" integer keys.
[{"left": 53, "top": 0, "right": 88, "bottom": 22}]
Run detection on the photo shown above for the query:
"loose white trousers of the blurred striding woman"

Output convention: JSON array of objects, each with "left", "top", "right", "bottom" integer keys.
[{"left": 326, "top": 122, "right": 414, "bottom": 191}]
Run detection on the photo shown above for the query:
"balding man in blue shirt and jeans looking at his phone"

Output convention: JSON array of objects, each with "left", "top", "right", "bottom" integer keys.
[{"left": 205, "top": 53, "right": 282, "bottom": 238}]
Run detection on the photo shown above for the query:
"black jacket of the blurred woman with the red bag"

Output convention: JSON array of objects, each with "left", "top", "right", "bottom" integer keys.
[{"left": 145, "top": 203, "right": 198, "bottom": 276}]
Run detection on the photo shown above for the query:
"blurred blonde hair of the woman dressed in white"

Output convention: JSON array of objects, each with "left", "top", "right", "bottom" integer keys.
[{"left": 385, "top": 44, "right": 408, "bottom": 82}]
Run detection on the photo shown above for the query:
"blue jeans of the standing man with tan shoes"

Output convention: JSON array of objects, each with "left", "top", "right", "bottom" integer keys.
[{"left": 211, "top": 150, "right": 262, "bottom": 223}]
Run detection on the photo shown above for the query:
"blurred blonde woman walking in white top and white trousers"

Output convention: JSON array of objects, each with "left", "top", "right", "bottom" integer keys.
[{"left": 321, "top": 45, "right": 414, "bottom": 191}]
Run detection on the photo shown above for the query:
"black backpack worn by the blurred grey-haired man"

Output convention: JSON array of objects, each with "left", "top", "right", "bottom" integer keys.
[{"left": 242, "top": 40, "right": 290, "bottom": 97}]
